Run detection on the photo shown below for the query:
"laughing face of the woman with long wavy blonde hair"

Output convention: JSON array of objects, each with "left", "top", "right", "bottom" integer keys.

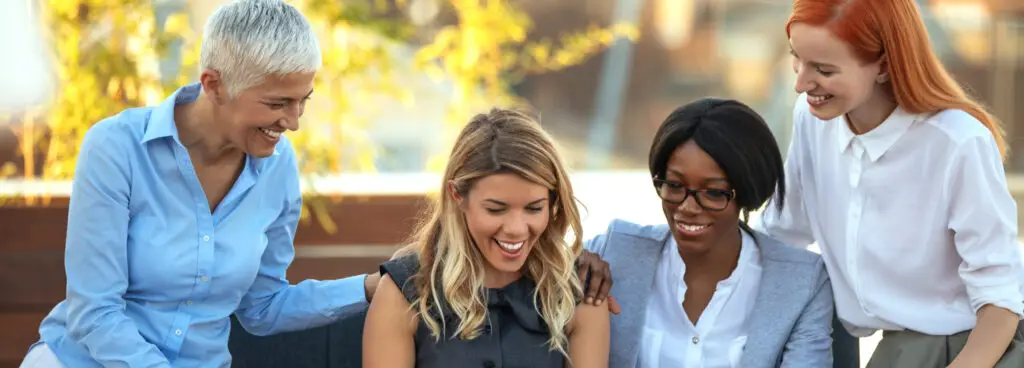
[{"left": 456, "top": 173, "right": 551, "bottom": 287}]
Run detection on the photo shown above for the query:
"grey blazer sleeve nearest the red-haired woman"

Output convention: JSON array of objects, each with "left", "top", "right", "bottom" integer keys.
[{"left": 780, "top": 260, "right": 836, "bottom": 368}]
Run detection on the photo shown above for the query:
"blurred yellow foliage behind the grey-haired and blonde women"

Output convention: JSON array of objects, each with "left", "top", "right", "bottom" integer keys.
[{"left": 0, "top": 0, "right": 637, "bottom": 232}]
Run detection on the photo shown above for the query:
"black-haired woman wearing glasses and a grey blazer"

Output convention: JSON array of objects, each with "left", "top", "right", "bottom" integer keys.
[{"left": 587, "top": 98, "right": 834, "bottom": 368}]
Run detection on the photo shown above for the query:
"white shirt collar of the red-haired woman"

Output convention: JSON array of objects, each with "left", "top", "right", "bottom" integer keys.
[{"left": 838, "top": 107, "right": 921, "bottom": 162}]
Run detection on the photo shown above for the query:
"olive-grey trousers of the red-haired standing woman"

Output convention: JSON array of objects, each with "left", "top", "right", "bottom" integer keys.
[{"left": 867, "top": 322, "right": 1024, "bottom": 368}]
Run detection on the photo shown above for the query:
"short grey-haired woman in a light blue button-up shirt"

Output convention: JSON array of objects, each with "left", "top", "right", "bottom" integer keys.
[{"left": 22, "top": 0, "right": 377, "bottom": 368}]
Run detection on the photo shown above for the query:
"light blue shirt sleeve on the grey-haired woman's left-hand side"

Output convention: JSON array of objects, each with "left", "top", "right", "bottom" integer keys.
[{"left": 65, "top": 118, "right": 170, "bottom": 367}]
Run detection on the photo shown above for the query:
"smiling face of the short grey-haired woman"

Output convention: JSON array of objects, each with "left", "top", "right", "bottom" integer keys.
[{"left": 204, "top": 73, "right": 315, "bottom": 157}]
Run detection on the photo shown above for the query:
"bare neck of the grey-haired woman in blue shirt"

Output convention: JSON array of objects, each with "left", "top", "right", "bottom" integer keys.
[{"left": 174, "top": 94, "right": 244, "bottom": 164}]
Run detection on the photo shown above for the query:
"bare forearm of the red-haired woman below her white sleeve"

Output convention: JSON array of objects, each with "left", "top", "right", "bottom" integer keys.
[{"left": 949, "top": 304, "right": 1020, "bottom": 368}]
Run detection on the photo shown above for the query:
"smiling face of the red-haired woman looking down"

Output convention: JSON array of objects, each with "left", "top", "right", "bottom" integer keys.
[{"left": 790, "top": 23, "right": 885, "bottom": 120}]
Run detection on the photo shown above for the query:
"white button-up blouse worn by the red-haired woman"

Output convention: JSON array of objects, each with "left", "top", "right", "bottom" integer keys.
[{"left": 756, "top": 95, "right": 1024, "bottom": 336}]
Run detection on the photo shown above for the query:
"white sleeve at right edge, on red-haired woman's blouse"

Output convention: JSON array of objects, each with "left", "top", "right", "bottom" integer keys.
[{"left": 948, "top": 135, "right": 1024, "bottom": 316}]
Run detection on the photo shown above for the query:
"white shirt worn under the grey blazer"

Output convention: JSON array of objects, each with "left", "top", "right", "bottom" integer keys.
[{"left": 637, "top": 231, "right": 761, "bottom": 368}]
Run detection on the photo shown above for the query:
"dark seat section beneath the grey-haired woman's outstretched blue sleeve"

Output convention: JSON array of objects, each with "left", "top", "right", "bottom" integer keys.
[{"left": 227, "top": 304, "right": 367, "bottom": 368}]
